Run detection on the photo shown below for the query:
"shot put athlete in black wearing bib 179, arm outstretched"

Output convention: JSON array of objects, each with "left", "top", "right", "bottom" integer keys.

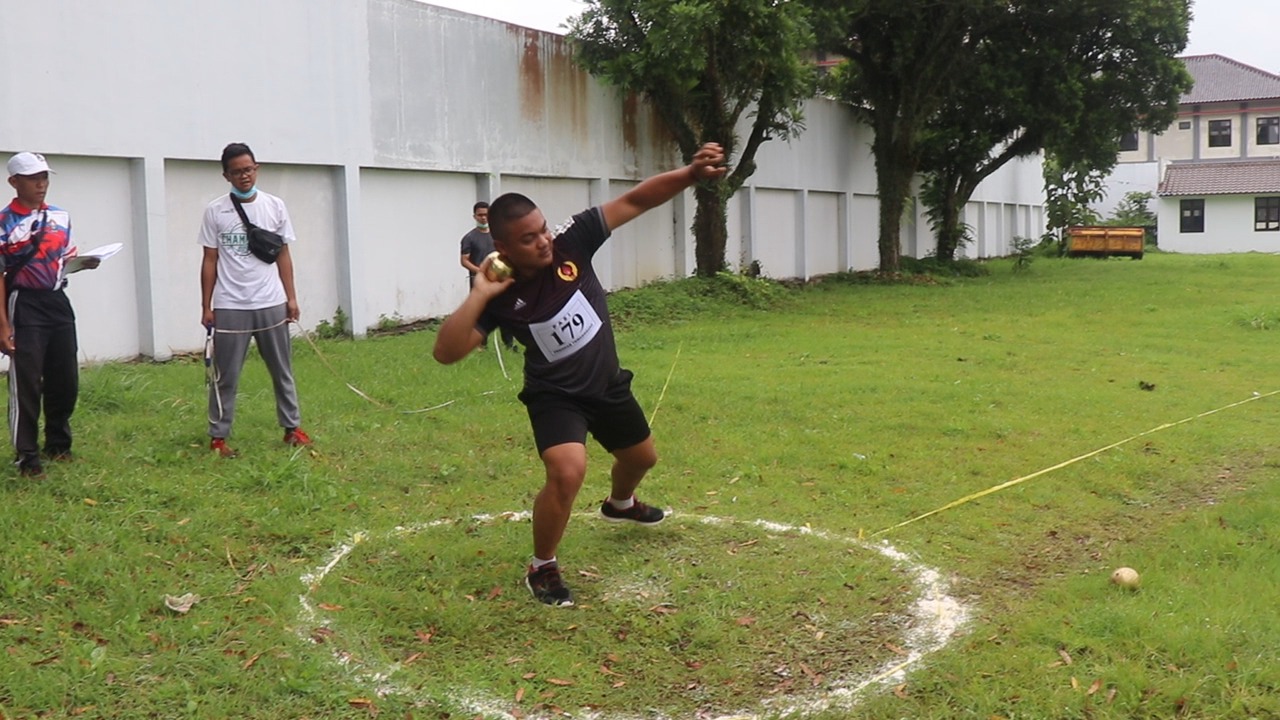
[{"left": 434, "top": 142, "right": 726, "bottom": 606}]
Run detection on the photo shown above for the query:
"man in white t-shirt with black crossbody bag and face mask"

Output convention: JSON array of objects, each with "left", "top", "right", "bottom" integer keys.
[{"left": 200, "top": 142, "right": 311, "bottom": 457}]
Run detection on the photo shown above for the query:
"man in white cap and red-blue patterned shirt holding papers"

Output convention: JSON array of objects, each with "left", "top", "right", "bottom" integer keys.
[{"left": 0, "top": 152, "right": 100, "bottom": 478}]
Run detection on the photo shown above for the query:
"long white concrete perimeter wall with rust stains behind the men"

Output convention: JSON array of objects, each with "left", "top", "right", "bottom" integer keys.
[{"left": 0, "top": 0, "right": 1042, "bottom": 360}]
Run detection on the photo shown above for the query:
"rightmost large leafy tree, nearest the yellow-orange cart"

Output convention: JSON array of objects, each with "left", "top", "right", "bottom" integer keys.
[{"left": 922, "top": 0, "right": 1190, "bottom": 260}]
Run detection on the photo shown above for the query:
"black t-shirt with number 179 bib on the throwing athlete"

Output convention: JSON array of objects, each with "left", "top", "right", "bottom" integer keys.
[{"left": 476, "top": 208, "right": 618, "bottom": 396}]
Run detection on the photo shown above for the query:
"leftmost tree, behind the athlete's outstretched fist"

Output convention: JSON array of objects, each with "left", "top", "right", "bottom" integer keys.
[{"left": 568, "top": 0, "right": 815, "bottom": 277}]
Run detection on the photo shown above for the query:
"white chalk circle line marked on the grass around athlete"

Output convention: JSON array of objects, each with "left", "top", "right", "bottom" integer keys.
[{"left": 298, "top": 512, "right": 972, "bottom": 720}]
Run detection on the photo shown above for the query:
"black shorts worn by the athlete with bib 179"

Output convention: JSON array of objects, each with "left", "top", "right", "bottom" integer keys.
[{"left": 520, "top": 370, "right": 650, "bottom": 455}]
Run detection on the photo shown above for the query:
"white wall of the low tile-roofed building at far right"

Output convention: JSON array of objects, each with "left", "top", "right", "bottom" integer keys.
[{"left": 1157, "top": 195, "right": 1280, "bottom": 254}]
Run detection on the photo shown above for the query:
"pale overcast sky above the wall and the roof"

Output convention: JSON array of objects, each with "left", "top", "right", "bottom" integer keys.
[{"left": 430, "top": 0, "right": 1280, "bottom": 74}]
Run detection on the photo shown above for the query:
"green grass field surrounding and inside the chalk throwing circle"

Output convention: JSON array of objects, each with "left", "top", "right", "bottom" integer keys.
[{"left": 0, "top": 254, "right": 1280, "bottom": 720}]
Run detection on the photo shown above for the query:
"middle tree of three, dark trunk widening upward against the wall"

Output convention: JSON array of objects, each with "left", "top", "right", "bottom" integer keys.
[{"left": 813, "top": 0, "right": 1006, "bottom": 272}]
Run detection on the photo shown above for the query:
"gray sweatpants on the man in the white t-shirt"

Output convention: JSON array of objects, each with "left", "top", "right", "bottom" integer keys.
[{"left": 209, "top": 305, "right": 302, "bottom": 438}]
